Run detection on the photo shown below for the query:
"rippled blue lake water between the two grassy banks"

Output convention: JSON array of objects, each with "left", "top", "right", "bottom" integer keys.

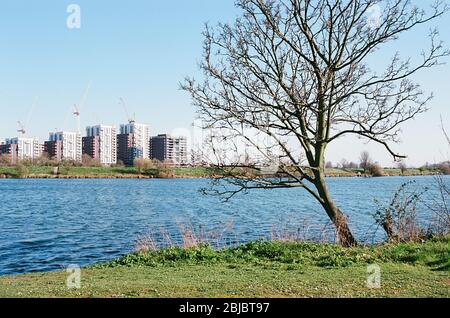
[{"left": 0, "top": 177, "right": 450, "bottom": 275}]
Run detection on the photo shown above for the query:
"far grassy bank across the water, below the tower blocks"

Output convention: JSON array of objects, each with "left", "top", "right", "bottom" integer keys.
[{"left": 0, "top": 166, "right": 438, "bottom": 179}]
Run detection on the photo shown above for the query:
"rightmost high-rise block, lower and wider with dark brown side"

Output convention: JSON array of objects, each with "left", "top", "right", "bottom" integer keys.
[{"left": 150, "top": 134, "right": 188, "bottom": 165}]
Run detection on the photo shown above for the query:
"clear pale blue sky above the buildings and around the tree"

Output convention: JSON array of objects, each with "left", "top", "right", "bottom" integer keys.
[{"left": 0, "top": 0, "right": 450, "bottom": 165}]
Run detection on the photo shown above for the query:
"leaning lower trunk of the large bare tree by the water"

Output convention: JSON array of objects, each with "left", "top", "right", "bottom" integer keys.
[{"left": 314, "top": 171, "right": 358, "bottom": 247}]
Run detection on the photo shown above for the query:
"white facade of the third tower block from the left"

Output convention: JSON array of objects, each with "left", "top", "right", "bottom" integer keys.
[{"left": 86, "top": 125, "right": 117, "bottom": 165}]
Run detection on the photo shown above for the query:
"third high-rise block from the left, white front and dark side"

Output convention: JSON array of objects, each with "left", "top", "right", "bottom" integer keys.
[{"left": 83, "top": 125, "right": 117, "bottom": 165}]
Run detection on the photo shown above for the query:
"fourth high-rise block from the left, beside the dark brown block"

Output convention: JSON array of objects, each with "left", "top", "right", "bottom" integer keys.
[{"left": 117, "top": 122, "right": 150, "bottom": 166}]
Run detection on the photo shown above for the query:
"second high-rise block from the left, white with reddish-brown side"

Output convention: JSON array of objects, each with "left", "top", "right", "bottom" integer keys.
[{"left": 45, "top": 131, "right": 82, "bottom": 162}]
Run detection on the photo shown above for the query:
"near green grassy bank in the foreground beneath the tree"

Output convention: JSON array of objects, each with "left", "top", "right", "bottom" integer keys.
[{"left": 0, "top": 238, "right": 450, "bottom": 297}]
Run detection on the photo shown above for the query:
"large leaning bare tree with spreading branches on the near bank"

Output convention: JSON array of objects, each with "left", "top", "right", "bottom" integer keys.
[{"left": 181, "top": 0, "right": 449, "bottom": 246}]
